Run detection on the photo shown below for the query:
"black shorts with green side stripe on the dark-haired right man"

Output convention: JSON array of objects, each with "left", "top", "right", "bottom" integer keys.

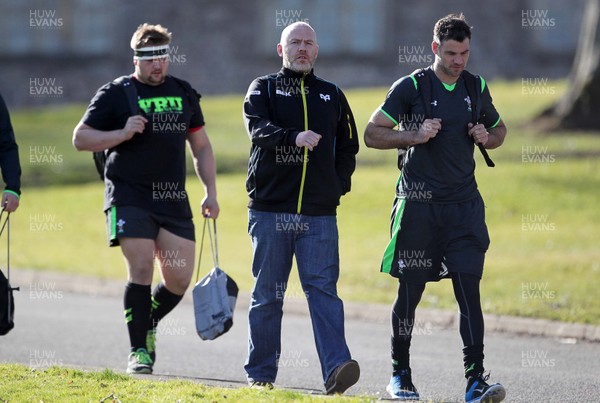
[{"left": 381, "top": 196, "right": 490, "bottom": 283}]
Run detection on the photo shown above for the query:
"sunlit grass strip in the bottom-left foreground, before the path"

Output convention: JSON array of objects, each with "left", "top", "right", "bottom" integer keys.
[{"left": 0, "top": 364, "right": 372, "bottom": 402}]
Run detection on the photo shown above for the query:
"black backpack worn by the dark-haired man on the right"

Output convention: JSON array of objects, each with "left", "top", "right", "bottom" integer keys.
[{"left": 398, "top": 69, "right": 496, "bottom": 170}]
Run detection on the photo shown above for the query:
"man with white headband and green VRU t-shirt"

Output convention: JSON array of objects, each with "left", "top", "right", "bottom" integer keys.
[{"left": 73, "top": 24, "right": 219, "bottom": 374}]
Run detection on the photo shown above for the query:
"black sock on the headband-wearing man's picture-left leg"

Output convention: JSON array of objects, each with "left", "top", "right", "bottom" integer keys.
[{"left": 123, "top": 283, "right": 151, "bottom": 351}]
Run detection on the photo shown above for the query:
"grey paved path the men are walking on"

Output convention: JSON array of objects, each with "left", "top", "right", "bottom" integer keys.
[{"left": 0, "top": 274, "right": 600, "bottom": 403}]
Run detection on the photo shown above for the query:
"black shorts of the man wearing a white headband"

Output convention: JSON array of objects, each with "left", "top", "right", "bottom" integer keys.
[{"left": 106, "top": 206, "right": 196, "bottom": 246}]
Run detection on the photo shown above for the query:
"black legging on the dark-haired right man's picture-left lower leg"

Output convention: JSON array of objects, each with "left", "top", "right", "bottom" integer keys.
[{"left": 391, "top": 282, "right": 425, "bottom": 375}]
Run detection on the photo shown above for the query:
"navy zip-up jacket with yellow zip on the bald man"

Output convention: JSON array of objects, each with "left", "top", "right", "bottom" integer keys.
[{"left": 244, "top": 68, "right": 359, "bottom": 215}]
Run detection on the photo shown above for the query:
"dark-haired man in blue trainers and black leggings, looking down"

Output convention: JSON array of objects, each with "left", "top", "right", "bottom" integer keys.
[{"left": 365, "top": 14, "right": 506, "bottom": 402}]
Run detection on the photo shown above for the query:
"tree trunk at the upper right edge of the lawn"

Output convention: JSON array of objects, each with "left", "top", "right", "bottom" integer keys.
[{"left": 540, "top": 0, "right": 600, "bottom": 131}]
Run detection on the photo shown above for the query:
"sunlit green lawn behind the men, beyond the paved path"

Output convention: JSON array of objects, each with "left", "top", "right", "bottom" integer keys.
[{"left": 12, "top": 82, "right": 600, "bottom": 324}]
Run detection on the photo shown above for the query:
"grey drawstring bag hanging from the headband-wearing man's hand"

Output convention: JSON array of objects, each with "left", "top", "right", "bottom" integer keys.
[{"left": 192, "top": 218, "right": 239, "bottom": 340}]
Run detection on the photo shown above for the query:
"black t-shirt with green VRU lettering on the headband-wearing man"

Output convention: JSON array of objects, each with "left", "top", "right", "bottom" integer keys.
[{"left": 83, "top": 76, "right": 204, "bottom": 218}]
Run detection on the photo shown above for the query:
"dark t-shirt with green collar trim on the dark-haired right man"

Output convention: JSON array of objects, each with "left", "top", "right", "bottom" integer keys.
[{"left": 381, "top": 69, "right": 500, "bottom": 203}]
